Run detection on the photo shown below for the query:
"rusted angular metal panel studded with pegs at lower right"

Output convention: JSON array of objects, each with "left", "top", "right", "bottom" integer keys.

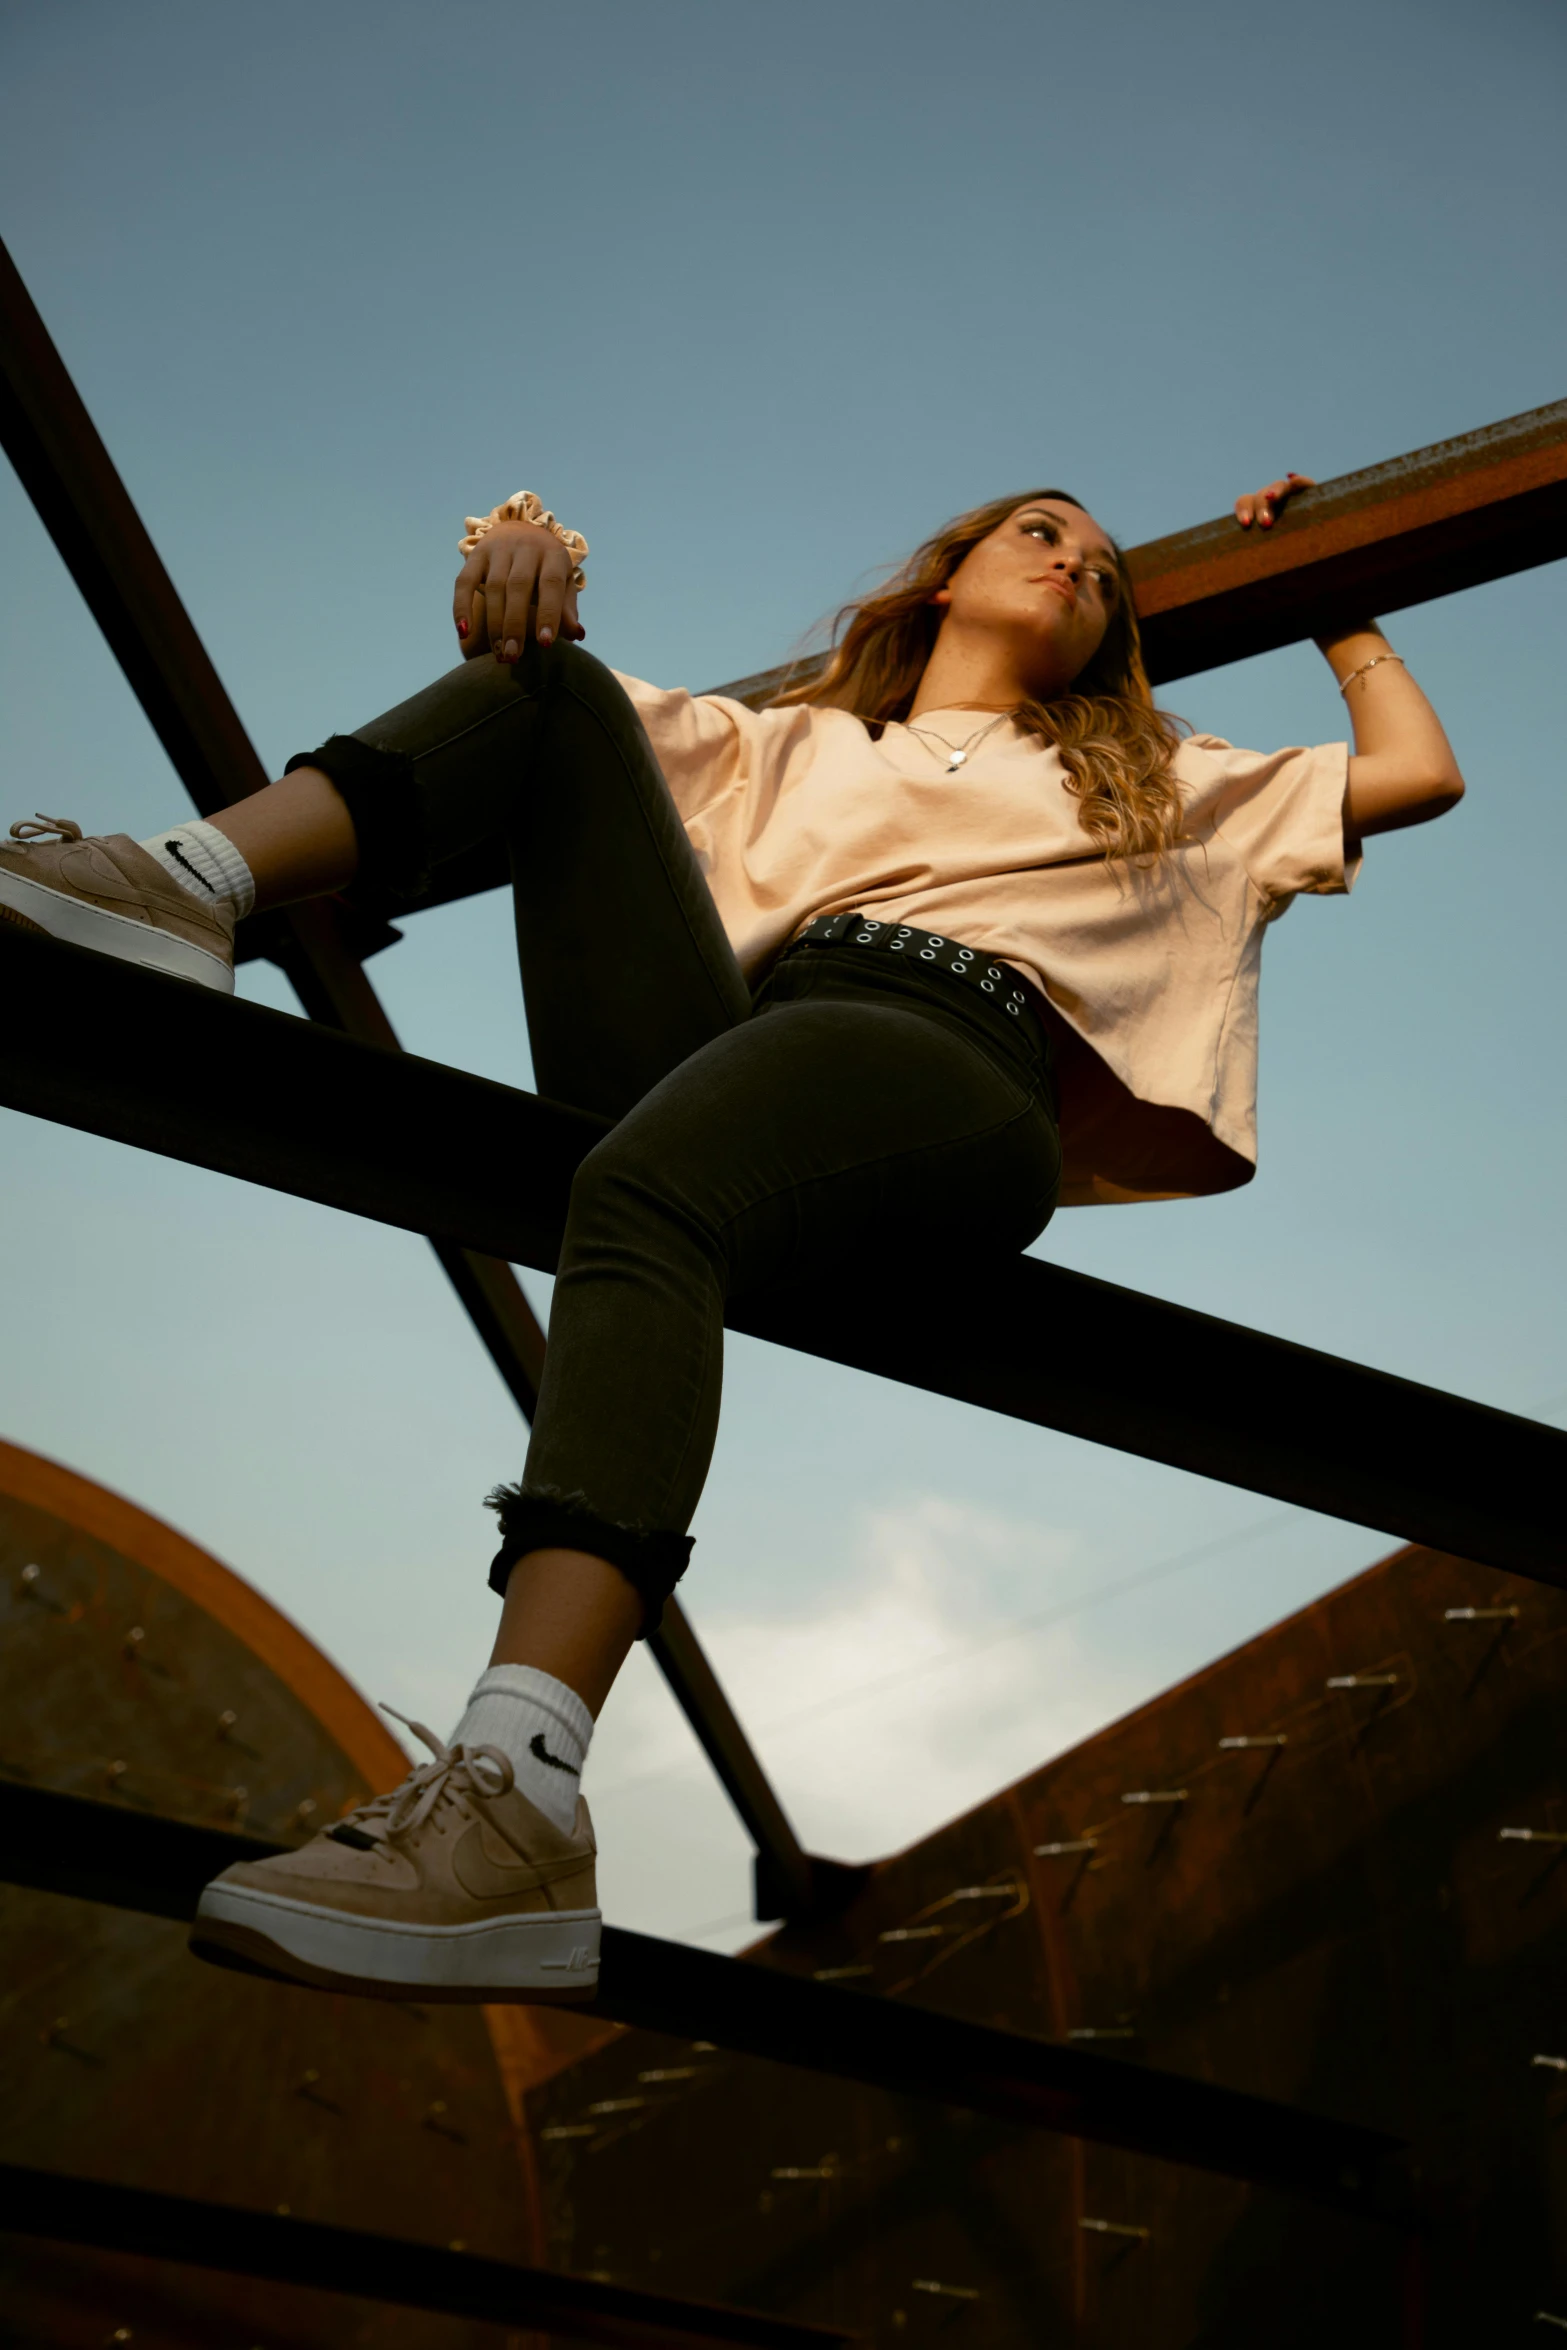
[{"left": 529, "top": 1551, "right": 1567, "bottom": 2350}]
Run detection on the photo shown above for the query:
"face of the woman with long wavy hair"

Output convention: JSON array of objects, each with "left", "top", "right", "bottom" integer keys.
[{"left": 933, "top": 498, "right": 1121, "bottom": 700}]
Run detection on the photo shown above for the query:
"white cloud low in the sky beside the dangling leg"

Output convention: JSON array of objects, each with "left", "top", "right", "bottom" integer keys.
[{"left": 575, "top": 1495, "right": 1144, "bottom": 1946}]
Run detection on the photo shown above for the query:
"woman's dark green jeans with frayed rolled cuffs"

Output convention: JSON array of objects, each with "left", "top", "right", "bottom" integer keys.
[{"left": 291, "top": 644, "right": 1060, "bottom": 1629}]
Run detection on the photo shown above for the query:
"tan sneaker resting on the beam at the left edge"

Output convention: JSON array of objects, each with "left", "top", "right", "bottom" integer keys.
[{"left": 0, "top": 815, "right": 235, "bottom": 996}]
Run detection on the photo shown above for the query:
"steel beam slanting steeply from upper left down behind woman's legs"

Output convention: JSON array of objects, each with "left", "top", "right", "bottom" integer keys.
[{"left": 0, "top": 244, "right": 846, "bottom": 1918}]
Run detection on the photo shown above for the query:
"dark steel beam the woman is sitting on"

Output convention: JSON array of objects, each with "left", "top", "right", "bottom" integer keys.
[{"left": 0, "top": 928, "right": 1567, "bottom": 1586}]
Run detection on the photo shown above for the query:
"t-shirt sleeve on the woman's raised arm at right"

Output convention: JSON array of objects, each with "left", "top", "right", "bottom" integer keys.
[{"left": 1182, "top": 736, "right": 1360, "bottom": 902}]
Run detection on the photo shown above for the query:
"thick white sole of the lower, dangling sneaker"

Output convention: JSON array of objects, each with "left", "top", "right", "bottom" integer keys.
[{"left": 190, "top": 1880, "right": 599, "bottom": 2000}]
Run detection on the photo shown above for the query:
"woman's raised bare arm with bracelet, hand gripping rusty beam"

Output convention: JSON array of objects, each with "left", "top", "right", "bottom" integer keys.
[{"left": 1236, "top": 472, "right": 1464, "bottom": 841}]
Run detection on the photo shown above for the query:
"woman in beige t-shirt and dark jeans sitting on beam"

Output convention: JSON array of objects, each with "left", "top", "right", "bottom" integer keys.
[{"left": 0, "top": 475, "right": 1464, "bottom": 2000}]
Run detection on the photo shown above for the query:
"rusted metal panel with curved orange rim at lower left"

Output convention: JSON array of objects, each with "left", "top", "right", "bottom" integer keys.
[{"left": 0, "top": 1445, "right": 566, "bottom": 2350}]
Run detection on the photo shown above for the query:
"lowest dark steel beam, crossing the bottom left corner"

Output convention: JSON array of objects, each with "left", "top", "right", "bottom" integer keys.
[{"left": 0, "top": 2162, "right": 855, "bottom": 2350}]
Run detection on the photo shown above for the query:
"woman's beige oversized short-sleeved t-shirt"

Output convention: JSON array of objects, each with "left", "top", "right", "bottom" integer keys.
[{"left": 620, "top": 677, "right": 1356, "bottom": 1206}]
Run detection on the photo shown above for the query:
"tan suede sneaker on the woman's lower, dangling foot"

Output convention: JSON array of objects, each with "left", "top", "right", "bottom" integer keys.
[{"left": 190, "top": 1706, "right": 599, "bottom": 2002}]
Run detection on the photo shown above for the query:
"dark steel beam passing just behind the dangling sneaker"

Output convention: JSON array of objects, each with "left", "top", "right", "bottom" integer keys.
[{"left": 0, "top": 1781, "right": 1412, "bottom": 2221}]
